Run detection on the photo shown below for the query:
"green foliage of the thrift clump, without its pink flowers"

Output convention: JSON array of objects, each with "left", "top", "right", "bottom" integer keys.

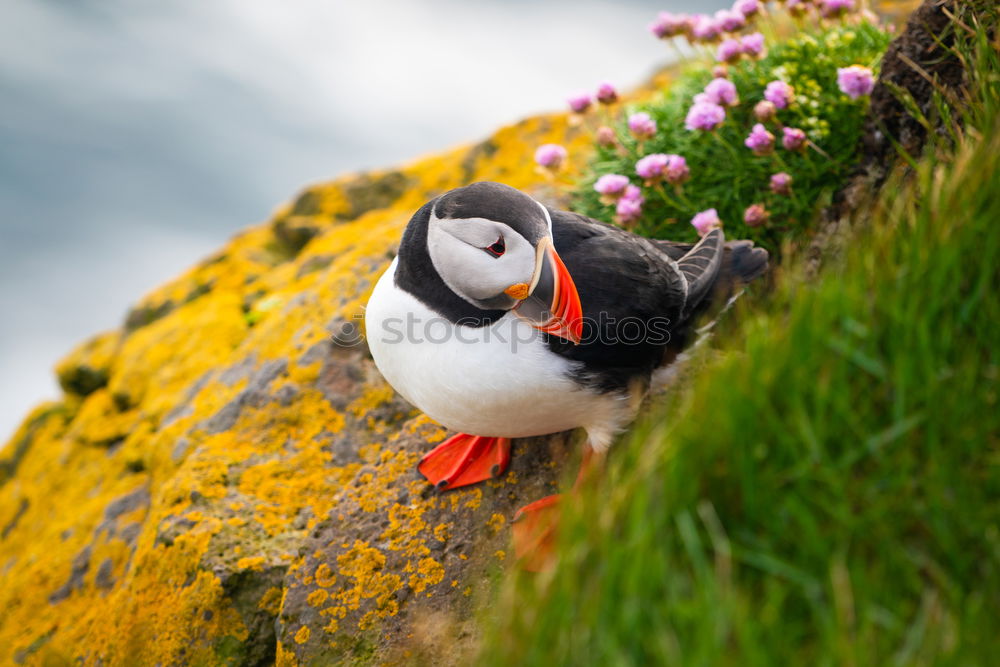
[{"left": 574, "top": 23, "right": 889, "bottom": 250}]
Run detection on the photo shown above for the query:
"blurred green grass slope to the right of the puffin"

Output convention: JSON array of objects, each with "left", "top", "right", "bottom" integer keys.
[{"left": 479, "top": 5, "right": 1000, "bottom": 666}]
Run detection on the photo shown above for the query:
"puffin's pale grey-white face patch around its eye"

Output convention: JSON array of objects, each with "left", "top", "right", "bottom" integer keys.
[{"left": 427, "top": 213, "right": 541, "bottom": 310}]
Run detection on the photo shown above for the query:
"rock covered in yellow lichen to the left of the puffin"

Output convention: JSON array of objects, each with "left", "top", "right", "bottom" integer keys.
[{"left": 0, "top": 102, "right": 588, "bottom": 665}]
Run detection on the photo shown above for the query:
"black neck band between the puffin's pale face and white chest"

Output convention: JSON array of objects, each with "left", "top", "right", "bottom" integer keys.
[{"left": 394, "top": 200, "right": 507, "bottom": 327}]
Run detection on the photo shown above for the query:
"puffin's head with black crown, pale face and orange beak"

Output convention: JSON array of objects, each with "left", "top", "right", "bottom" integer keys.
[{"left": 411, "top": 182, "right": 582, "bottom": 342}]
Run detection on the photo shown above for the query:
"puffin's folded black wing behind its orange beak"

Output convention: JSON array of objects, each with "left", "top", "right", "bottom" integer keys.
[{"left": 548, "top": 210, "right": 704, "bottom": 391}]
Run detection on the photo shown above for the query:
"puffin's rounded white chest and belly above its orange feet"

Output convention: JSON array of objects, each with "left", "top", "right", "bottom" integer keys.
[{"left": 365, "top": 261, "right": 608, "bottom": 437}]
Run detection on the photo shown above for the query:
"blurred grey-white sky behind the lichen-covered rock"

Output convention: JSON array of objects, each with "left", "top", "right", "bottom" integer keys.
[{"left": 0, "top": 0, "right": 723, "bottom": 447}]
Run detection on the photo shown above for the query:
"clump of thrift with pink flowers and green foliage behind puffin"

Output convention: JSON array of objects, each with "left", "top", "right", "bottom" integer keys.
[{"left": 564, "top": 0, "right": 889, "bottom": 250}]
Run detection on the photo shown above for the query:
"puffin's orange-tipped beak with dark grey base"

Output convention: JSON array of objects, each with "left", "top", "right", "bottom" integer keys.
[{"left": 514, "top": 238, "right": 583, "bottom": 344}]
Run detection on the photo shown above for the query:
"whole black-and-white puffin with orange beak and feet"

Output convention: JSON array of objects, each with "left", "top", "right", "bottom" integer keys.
[{"left": 365, "top": 182, "right": 768, "bottom": 564}]
